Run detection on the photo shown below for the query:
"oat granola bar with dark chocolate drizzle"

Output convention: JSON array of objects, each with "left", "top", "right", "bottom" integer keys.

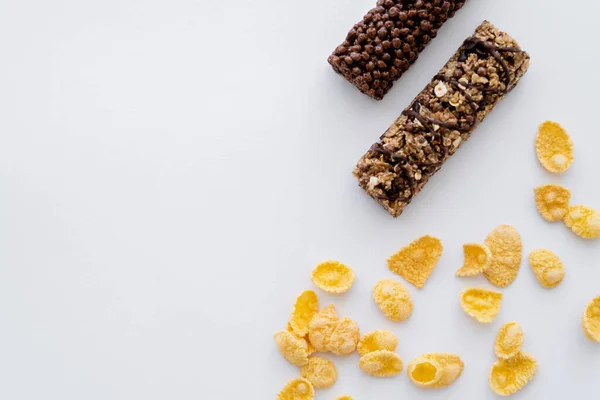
[{"left": 354, "top": 21, "right": 529, "bottom": 217}]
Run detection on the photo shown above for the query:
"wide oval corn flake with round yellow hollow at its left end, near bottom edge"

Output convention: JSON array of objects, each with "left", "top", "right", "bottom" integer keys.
[{"left": 406, "top": 353, "right": 464, "bottom": 389}]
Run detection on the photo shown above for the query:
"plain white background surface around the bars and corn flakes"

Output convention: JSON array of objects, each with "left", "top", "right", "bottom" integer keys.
[{"left": 0, "top": 0, "right": 600, "bottom": 400}]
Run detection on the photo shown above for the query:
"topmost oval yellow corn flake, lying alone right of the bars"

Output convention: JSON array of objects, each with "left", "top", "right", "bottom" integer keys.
[{"left": 535, "top": 121, "right": 573, "bottom": 173}]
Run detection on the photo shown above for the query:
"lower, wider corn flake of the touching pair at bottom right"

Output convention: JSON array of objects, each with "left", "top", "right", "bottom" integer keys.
[{"left": 490, "top": 353, "right": 538, "bottom": 396}]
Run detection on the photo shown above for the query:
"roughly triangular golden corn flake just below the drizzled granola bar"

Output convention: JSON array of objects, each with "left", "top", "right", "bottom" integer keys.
[{"left": 388, "top": 235, "right": 444, "bottom": 289}]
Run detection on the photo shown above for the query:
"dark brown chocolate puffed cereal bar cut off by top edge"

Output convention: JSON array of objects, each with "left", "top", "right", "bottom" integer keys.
[{"left": 328, "top": 0, "right": 466, "bottom": 100}]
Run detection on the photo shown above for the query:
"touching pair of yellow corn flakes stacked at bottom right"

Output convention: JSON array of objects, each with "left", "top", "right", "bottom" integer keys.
[{"left": 490, "top": 322, "right": 538, "bottom": 396}]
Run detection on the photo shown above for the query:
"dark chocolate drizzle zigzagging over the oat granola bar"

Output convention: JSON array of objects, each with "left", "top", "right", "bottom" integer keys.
[{"left": 370, "top": 30, "right": 524, "bottom": 202}]
